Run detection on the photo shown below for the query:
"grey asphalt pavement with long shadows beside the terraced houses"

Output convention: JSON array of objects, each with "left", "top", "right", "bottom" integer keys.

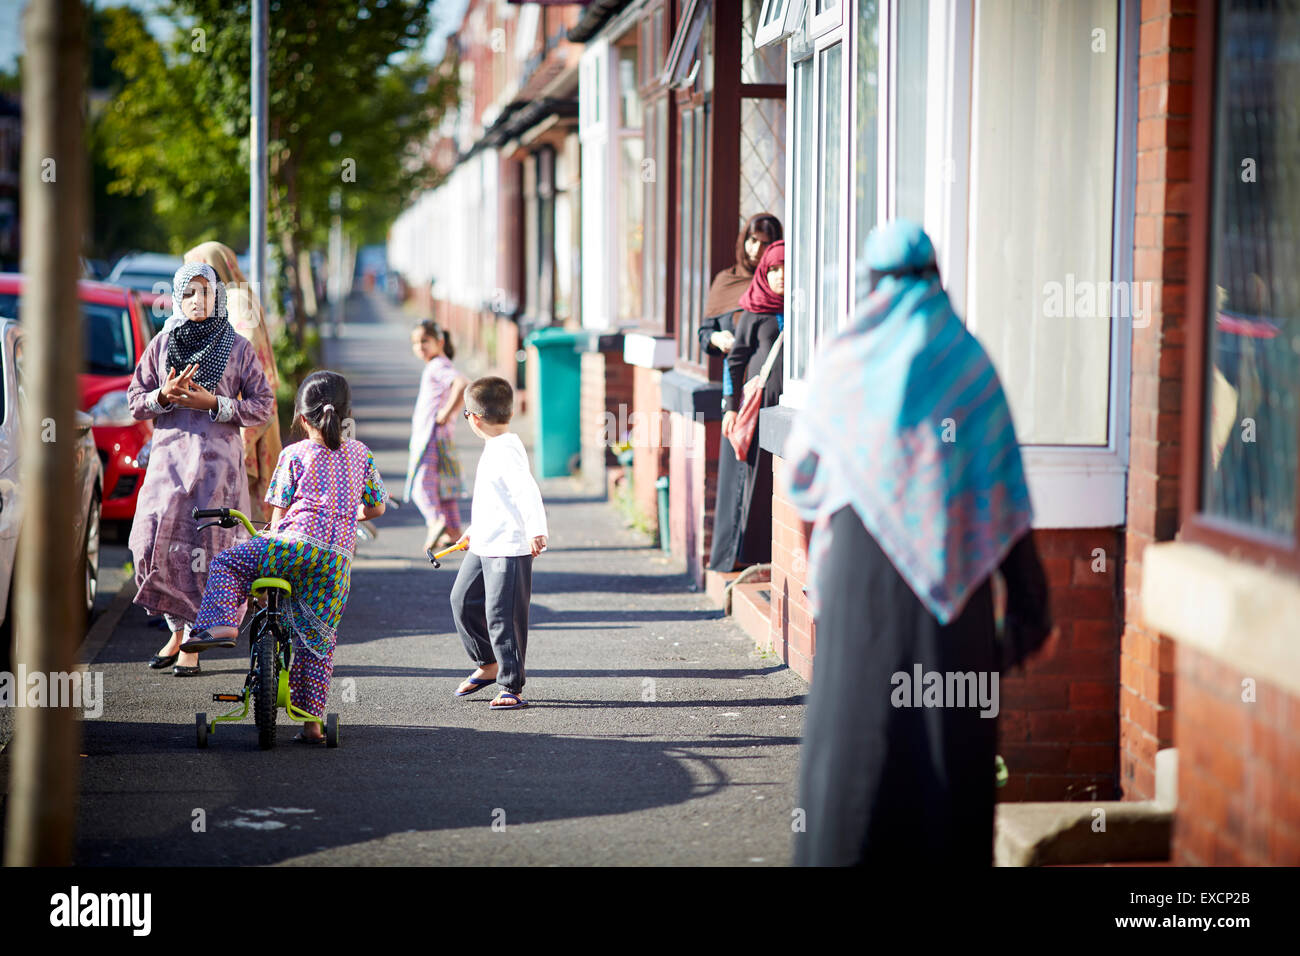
[{"left": 0, "top": 295, "right": 807, "bottom": 866}]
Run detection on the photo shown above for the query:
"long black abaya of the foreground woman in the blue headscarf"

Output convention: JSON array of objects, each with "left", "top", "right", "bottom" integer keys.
[{"left": 794, "top": 507, "right": 1050, "bottom": 866}]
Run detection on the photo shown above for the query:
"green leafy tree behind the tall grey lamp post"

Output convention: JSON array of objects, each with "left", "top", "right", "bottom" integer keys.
[{"left": 96, "top": 0, "right": 456, "bottom": 337}]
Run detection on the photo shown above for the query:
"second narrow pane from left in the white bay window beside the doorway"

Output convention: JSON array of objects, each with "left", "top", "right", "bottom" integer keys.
[{"left": 814, "top": 43, "right": 847, "bottom": 349}]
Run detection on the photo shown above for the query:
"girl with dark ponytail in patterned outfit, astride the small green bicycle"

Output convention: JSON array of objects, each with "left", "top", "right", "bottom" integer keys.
[{"left": 182, "top": 372, "right": 387, "bottom": 743}]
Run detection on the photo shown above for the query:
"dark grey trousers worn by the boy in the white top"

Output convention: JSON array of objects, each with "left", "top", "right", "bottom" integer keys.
[{"left": 451, "top": 551, "right": 533, "bottom": 693}]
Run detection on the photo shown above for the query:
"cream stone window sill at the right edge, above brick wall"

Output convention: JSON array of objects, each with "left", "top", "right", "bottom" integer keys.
[{"left": 1141, "top": 541, "right": 1300, "bottom": 695}]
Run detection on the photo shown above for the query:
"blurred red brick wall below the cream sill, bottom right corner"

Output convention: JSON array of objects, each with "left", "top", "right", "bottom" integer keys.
[{"left": 1173, "top": 645, "right": 1300, "bottom": 866}]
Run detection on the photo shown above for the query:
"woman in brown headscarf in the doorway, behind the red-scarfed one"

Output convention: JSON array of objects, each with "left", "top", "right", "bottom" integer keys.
[{"left": 699, "top": 212, "right": 781, "bottom": 571}]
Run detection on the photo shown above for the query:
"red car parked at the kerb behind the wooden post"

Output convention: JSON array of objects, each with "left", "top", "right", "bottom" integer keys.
[{"left": 0, "top": 273, "right": 156, "bottom": 522}]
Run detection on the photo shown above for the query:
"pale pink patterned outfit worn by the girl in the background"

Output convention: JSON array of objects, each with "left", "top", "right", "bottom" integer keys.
[{"left": 404, "top": 355, "right": 462, "bottom": 531}]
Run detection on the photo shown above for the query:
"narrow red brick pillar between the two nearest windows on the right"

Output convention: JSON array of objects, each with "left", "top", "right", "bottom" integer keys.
[{"left": 1119, "top": 0, "right": 1196, "bottom": 800}]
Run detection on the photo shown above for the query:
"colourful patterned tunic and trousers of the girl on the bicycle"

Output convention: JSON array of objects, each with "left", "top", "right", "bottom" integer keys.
[{"left": 195, "top": 440, "right": 387, "bottom": 715}]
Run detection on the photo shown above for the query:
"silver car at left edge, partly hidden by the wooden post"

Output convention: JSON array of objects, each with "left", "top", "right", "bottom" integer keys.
[{"left": 0, "top": 311, "right": 104, "bottom": 670}]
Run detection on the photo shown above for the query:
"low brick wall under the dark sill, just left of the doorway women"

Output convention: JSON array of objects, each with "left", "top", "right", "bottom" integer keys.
[{"left": 666, "top": 412, "right": 731, "bottom": 588}]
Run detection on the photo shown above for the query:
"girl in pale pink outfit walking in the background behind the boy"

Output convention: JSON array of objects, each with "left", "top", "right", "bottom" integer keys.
[{"left": 402, "top": 319, "right": 469, "bottom": 550}]
